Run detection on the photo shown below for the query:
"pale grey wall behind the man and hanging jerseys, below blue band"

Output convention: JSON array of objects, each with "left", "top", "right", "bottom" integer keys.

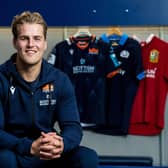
[{"left": 0, "top": 26, "right": 168, "bottom": 166}]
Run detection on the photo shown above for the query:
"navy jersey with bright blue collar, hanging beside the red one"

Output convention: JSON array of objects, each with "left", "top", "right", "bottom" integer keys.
[{"left": 96, "top": 34, "right": 144, "bottom": 135}]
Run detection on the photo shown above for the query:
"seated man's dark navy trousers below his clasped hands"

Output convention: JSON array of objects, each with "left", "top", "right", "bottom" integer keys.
[{"left": 0, "top": 146, "right": 98, "bottom": 168}]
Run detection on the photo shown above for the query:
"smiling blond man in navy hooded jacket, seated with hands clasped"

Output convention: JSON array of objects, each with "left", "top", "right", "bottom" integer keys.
[{"left": 0, "top": 11, "right": 98, "bottom": 168}]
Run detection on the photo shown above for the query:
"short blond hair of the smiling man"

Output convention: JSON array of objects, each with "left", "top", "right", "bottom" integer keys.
[{"left": 11, "top": 11, "right": 47, "bottom": 39}]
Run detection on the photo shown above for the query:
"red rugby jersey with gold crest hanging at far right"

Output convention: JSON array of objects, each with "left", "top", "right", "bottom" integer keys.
[{"left": 129, "top": 36, "right": 168, "bottom": 135}]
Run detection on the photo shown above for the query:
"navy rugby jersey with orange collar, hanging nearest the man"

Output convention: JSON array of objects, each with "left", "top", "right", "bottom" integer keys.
[{"left": 48, "top": 36, "right": 113, "bottom": 124}]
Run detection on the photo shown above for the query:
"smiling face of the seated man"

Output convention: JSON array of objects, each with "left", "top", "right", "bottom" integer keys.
[{"left": 13, "top": 23, "right": 47, "bottom": 66}]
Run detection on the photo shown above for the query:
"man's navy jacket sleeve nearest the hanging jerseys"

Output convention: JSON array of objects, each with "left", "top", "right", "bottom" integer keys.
[{"left": 58, "top": 73, "right": 82, "bottom": 152}]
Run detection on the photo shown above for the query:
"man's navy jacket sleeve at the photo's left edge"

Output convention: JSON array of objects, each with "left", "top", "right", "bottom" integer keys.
[{"left": 0, "top": 83, "right": 32, "bottom": 155}]
